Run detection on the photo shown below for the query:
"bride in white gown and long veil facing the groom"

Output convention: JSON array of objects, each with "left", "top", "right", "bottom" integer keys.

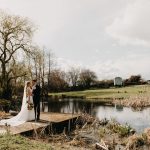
[{"left": 0, "top": 81, "right": 35, "bottom": 126}]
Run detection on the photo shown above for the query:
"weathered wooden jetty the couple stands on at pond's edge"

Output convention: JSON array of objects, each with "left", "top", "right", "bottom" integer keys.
[{"left": 0, "top": 113, "right": 80, "bottom": 135}]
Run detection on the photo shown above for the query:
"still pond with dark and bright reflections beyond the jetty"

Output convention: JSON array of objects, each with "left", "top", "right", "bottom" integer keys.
[{"left": 43, "top": 99, "right": 150, "bottom": 132}]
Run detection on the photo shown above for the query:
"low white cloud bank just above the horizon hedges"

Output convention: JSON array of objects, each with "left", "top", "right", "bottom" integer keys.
[{"left": 57, "top": 53, "right": 150, "bottom": 80}]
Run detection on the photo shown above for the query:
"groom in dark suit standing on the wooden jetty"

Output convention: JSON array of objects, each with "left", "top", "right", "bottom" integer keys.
[{"left": 32, "top": 80, "right": 41, "bottom": 121}]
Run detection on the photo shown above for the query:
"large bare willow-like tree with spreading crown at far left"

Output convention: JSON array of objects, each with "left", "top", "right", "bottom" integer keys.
[{"left": 0, "top": 12, "right": 33, "bottom": 99}]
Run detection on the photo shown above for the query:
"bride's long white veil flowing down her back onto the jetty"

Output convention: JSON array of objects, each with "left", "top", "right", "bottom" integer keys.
[{"left": 0, "top": 81, "right": 29, "bottom": 126}]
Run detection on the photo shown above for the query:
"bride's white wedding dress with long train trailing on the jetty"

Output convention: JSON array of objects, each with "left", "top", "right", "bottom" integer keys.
[{"left": 0, "top": 83, "right": 35, "bottom": 126}]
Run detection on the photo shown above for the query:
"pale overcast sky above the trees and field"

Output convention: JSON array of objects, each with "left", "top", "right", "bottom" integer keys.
[{"left": 0, "top": 0, "right": 150, "bottom": 79}]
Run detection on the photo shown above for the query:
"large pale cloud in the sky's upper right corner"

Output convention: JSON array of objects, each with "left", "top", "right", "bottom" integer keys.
[{"left": 106, "top": 0, "right": 150, "bottom": 46}]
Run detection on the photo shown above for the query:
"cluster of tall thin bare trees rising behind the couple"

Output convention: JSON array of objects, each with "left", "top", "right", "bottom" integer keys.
[{"left": 26, "top": 46, "right": 56, "bottom": 95}]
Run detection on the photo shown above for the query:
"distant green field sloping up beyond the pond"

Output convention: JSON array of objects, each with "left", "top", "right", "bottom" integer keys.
[{"left": 49, "top": 85, "right": 150, "bottom": 100}]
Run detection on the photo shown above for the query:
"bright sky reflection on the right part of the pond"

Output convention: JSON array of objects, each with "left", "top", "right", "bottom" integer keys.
[{"left": 96, "top": 106, "right": 150, "bottom": 132}]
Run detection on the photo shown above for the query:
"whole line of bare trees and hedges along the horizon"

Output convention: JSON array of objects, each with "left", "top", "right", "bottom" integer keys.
[{"left": 0, "top": 12, "right": 148, "bottom": 100}]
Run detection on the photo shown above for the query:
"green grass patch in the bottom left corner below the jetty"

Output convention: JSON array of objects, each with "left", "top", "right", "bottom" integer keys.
[{"left": 0, "top": 134, "right": 52, "bottom": 150}]
